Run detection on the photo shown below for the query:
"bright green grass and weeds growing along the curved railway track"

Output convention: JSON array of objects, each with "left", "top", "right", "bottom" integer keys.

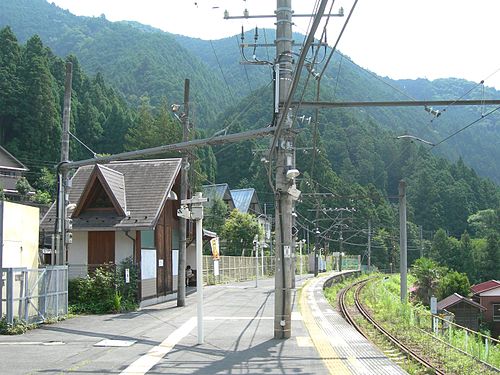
[{"left": 325, "top": 275, "right": 500, "bottom": 375}]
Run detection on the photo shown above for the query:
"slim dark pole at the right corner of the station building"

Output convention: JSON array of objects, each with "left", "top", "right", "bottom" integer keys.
[{"left": 177, "top": 79, "right": 189, "bottom": 307}]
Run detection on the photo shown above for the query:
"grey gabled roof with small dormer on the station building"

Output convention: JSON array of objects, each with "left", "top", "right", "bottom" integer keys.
[{"left": 41, "top": 159, "right": 181, "bottom": 231}]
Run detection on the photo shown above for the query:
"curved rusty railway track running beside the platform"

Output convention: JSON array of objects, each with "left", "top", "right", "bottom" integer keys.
[{"left": 339, "top": 279, "right": 445, "bottom": 375}]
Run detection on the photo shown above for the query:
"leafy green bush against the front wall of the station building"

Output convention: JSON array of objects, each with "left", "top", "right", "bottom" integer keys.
[{"left": 68, "top": 258, "right": 138, "bottom": 314}]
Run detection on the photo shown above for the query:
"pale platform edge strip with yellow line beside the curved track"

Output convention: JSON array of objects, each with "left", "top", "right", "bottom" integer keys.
[{"left": 300, "top": 274, "right": 407, "bottom": 375}]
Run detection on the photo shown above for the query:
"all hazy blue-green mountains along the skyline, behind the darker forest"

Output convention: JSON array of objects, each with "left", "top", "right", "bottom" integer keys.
[{"left": 0, "top": 0, "right": 500, "bottom": 183}]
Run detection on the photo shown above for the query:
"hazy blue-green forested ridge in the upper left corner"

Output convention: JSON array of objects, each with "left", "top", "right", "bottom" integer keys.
[{"left": 0, "top": 0, "right": 230, "bottom": 123}]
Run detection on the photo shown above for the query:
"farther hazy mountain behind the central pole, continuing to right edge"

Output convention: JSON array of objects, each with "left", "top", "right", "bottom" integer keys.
[{"left": 175, "top": 30, "right": 500, "bottom": 183}]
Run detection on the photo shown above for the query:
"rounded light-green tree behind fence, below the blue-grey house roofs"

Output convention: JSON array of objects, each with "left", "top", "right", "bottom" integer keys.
[{"left": 221, "top": 209, "right": 262, "bottom": 255}]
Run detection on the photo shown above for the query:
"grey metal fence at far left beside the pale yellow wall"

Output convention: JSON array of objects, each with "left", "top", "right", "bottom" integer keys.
[{"left": 0, "top": 266, "right": 68, "bottom": 324}]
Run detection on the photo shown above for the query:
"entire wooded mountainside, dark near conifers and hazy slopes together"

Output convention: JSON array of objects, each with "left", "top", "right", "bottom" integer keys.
[{"left": 0, "top": 0, "right": 500, "bottom": 281}]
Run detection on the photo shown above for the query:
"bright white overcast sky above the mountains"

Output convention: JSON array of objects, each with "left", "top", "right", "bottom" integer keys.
[{"left": 49, "top": 0, "right": 500, "bottom": 89}]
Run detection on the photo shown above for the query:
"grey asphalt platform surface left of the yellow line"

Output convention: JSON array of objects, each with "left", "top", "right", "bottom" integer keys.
[{"left": 0, "top": 279, "right": 406, "bottom": 375}]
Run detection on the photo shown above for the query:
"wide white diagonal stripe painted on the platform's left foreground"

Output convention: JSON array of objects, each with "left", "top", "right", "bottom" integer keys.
[{"left": 120, "top": 317, "right": 196, "bottom": 375}]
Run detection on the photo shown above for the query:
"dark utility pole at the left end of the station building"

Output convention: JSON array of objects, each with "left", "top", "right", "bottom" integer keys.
[{"left": 56, "top": 62, "right": 73, "bottom": 265}]
